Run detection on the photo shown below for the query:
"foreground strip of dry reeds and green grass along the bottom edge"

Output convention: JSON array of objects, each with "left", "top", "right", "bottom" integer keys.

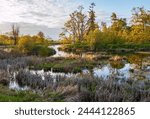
[{"left": 0, "top": 68, "right": 150, "bottom": 102}]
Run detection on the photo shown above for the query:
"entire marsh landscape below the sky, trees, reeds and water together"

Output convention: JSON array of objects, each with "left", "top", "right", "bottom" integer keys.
[{"left": 0, "top": 3, "right": 150, "bottom": 102}]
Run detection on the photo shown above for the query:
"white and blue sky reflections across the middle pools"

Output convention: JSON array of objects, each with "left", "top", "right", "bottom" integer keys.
[{"left": 26, "top": 64, "right": 134, "bottom": 80}]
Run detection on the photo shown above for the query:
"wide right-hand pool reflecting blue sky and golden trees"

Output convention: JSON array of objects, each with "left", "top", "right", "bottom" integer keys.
[{"left": 93, "top": 54, "right": 150, "bottom": 80}]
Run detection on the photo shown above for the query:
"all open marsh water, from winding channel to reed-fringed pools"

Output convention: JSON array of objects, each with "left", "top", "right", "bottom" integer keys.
[{"left": 9, "top": 45, "right": 150, "bottom": 90}]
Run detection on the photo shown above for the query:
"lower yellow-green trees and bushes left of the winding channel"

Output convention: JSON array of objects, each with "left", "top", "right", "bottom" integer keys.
[{"left": 0, "top": 24, "right": 55, "bottom": 56}]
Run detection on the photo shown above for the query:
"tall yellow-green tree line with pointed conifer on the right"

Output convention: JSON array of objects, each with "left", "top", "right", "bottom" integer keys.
[{"left": 60, "top": 3, "right": 150, "bottom": 50}]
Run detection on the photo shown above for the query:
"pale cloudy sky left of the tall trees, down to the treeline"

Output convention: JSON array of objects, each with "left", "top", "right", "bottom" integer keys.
[{"left": 0, "top": 0, "right": 113, "bottom": 39}]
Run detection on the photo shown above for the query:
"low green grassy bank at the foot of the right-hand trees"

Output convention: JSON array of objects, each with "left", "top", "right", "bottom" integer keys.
[{"left": 60, "top": 43, "right": 150, "bottom": 54}]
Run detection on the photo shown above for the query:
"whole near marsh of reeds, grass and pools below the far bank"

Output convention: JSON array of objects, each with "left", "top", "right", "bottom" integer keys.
[{"left": 0, "top": 47, "right": 150, "bottom": 101}]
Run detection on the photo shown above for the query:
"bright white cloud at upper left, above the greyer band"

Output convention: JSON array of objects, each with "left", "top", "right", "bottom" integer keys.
[{"left": 0, "top": 0, "right": 80, "bottom": 28}]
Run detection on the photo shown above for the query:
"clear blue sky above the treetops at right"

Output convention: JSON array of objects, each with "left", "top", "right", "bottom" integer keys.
[{"left": 77, "top": 0, "right": 150, "bottom": 20}]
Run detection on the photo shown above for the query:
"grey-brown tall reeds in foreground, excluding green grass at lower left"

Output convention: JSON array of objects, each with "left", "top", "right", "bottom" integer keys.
[{"left": 13, "top": 71, "right": 150, "bottom": 102}]
